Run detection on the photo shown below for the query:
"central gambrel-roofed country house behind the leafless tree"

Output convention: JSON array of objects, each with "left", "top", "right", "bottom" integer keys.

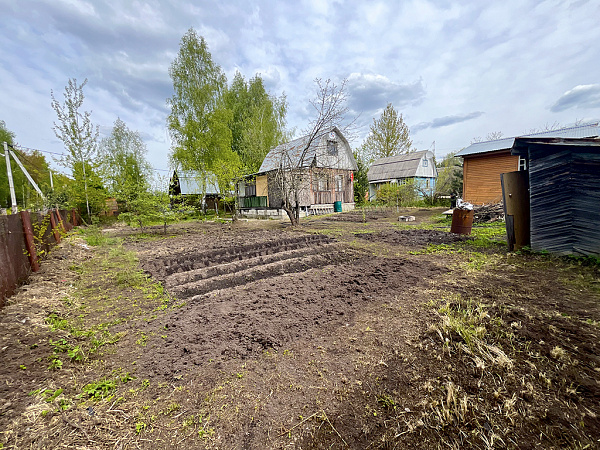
[{"left": 238, "top": 127, "right": 358, "bottom": 217}]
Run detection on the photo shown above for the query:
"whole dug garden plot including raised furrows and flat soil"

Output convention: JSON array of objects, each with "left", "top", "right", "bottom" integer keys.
[{"left": 138, "top": 232, "right": 439, "bottom": 379}]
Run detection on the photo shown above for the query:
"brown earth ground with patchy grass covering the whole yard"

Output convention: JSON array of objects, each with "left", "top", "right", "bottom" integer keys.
[{"left": 0, "top": 210, "right": 600, "bottom": 449}]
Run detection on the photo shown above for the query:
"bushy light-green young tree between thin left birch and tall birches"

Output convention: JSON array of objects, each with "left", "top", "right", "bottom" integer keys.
[{"left": 100, "top": 119, "right": 152, "bottom": 206}]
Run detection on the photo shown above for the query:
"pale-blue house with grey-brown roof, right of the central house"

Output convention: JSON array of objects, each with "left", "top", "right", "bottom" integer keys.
[{"left": 367, "top": 150, "right": 437, "bottom": 200}]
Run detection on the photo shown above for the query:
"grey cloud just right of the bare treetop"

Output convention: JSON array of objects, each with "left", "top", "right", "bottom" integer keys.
[{"left": 348, "top": 73, "right": 426, "bottom": 113}]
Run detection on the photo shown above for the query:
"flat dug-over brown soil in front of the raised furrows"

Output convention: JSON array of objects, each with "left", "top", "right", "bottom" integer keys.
[{"left": 138, "top": 253, "right": 440, "bottom": 378}]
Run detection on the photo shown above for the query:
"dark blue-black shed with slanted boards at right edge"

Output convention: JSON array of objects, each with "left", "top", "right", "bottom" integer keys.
[{"left": 511, "top": 137, "right": 600, "bottom": 257}]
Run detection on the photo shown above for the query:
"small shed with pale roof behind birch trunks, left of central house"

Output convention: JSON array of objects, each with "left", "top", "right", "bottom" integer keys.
[{"left": 169, "top": 170, "right": 225, "bottom": 209}]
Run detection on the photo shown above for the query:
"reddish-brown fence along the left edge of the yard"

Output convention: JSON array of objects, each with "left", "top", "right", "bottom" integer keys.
[{"left": 0, "top": 210, "right": 78, "bottom": 307}]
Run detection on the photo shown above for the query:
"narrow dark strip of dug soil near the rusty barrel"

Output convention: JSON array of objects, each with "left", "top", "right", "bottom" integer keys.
[{"left": 355, "top": 229, "right": 473, "bottom": 248}]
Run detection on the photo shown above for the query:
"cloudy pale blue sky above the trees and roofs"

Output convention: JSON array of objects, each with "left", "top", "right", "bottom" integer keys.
[{"left": 0, "top": 0, "right": 600, "bottom": 179}]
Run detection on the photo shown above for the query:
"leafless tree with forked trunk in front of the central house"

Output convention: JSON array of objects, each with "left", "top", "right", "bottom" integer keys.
[{"left": 272, "top": 78, "right": 353, "bottom": 226}]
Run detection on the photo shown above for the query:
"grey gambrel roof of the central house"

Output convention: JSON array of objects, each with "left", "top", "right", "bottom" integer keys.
[{"left": 258, "top": 127, "right": 357, "bottom": 173}]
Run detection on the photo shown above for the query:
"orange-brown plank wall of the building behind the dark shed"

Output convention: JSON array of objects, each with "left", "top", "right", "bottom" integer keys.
[{"left": 463, "top": 150, "right": 519, "bottom": 205}]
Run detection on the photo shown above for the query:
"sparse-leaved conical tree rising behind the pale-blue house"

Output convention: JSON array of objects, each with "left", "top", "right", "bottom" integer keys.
[{"left": 360, "top": 103, "right": 412, "bottom": 164}]
